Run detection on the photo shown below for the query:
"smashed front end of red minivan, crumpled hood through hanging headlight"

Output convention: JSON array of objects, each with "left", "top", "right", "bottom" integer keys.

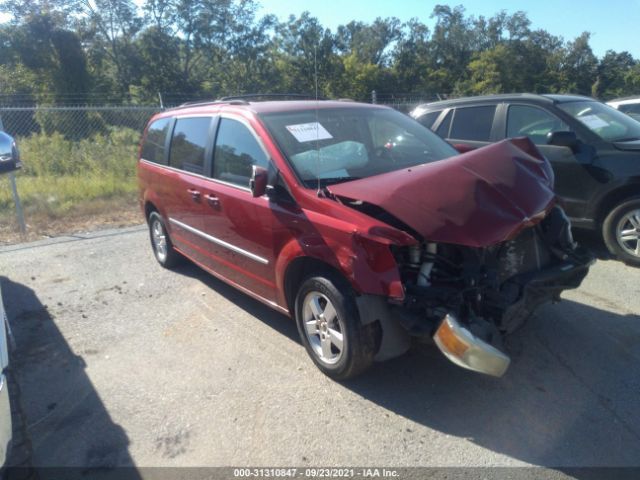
[{"left": 330, "top": 139, "right": 593, "bottom": 376}]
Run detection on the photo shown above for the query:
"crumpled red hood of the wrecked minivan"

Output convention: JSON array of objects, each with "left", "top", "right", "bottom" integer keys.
[{"left": 327, "top": 138, "right": 555, "bottom": 247}]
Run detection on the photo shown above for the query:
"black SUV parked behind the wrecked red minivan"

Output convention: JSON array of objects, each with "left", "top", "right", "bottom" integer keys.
[{"left": 411, "top": 94, "right": 640, "bottom": 266}]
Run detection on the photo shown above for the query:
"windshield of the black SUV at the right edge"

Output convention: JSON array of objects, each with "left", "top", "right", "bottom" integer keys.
[{"left": 558, "top": 101, "right": 640, "bottom": 142}]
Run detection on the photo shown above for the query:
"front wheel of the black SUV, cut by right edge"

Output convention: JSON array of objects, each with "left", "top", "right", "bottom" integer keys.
[{"left": 602, "top": 197, "right": 640, "bottom": 267}]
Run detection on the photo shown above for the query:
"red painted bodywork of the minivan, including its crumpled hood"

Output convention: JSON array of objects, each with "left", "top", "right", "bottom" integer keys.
[{"left": 138, "top": 102, "right": 554, "bottom": 311}]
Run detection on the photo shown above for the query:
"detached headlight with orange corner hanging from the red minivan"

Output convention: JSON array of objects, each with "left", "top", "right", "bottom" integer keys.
[{"left": 433, "top": 313, "right": 511, "bottom": 377}]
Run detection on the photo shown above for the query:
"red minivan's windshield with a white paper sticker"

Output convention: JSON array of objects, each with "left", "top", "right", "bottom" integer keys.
[{"left": 261, "top": 108, "right": 458, "bottom": 188}]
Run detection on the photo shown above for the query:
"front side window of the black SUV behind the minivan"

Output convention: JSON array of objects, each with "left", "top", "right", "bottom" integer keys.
[{"left": 507, "top": 105, "right": 571, "bottom": 145}]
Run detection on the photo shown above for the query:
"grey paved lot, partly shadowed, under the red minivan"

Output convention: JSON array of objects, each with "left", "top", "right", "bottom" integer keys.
[{"left": 0, "top": 227, "right": 640, "bottom": 467}]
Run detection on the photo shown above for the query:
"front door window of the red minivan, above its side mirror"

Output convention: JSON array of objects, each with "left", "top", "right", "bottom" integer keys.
[{"left": 213, "top": 118, "right": 269, "bottom": 187}]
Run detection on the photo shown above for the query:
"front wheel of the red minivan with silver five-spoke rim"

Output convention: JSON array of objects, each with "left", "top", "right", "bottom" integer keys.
[{"left": 295, "top": 272, "right": 376, "bottom": 380}]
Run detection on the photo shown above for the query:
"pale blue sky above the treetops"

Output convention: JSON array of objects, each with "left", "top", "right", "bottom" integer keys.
[{"left": 258, "top": 0, "right": 640, "bottom": 58}]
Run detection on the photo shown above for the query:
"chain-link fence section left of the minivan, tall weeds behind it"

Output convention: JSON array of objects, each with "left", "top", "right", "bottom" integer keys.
[{"left": 0, "top": 106, "right": 161, "bottom": 243}]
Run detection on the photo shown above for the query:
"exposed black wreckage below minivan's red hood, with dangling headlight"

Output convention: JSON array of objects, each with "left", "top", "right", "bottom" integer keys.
[{"left": 391, "top": 207, "right": 593, "bottom": 376}]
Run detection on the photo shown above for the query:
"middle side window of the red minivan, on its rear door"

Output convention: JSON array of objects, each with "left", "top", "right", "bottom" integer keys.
[{"left": 169, "top": 117, "right": 211, "bottom": 175}]
